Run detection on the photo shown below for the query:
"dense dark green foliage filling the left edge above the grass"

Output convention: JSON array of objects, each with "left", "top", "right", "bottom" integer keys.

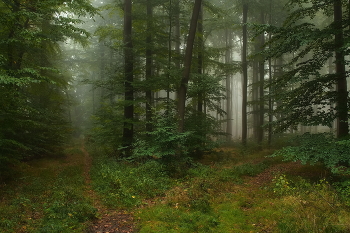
[{"left": 0, "top": 0, "right": 97, "bottom": 178}]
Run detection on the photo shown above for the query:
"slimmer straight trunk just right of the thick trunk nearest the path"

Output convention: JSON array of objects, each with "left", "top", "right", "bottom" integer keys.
[{"left": 146, "top": 0, "right": 153, "bottom": 132}]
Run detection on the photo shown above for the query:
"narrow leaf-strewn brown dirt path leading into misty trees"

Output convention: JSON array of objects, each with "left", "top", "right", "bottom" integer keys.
[{"left": 81, "top": 145, "right": 134, "bottom": 233}]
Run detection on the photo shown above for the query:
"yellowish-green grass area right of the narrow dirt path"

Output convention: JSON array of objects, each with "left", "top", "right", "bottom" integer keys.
[{"left": 123, "top": 148, "right": 350, "bottom": 233}]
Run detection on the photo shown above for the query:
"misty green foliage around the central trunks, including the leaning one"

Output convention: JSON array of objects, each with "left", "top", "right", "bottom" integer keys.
[{"left": 90, "top": 1, "right": 230, "bottom": 160}]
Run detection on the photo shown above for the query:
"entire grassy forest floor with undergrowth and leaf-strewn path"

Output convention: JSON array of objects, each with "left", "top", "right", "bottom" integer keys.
[{"left": 0, "top": 143, "right": 350, "bottom": 233}]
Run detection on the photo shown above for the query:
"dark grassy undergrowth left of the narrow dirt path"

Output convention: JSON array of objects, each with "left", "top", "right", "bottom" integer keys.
[{"left": 0, "top": 146, "right": 96, "bottom": 233}]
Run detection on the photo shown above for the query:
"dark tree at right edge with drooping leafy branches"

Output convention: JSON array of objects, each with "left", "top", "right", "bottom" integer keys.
[{"left": 261, "top": 1, "right": 349, "bottom": 137}]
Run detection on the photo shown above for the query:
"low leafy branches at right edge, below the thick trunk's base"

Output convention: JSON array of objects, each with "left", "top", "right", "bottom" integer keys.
[{"left": 271, "top": 133, "right": 350, "bottom": 174}]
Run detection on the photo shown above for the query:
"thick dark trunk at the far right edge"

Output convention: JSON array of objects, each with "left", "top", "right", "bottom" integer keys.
[{"left": 333, "top": 0, "right": 349, "bottom": 138}]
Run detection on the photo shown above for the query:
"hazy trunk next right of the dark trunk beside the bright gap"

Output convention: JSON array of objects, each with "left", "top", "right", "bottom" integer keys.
[{"left": 258, "top": 10, "right": 265, "bottom": 143}]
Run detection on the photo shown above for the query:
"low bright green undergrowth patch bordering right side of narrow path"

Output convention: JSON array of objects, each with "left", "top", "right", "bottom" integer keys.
[{"left": 92, "top": 148, "right": 171, "bottom": 207}]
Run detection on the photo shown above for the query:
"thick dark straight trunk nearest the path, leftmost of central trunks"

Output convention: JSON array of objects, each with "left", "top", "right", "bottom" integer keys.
[{"left": 123, "top": 0, "right": 134, "bottom": 157}]
